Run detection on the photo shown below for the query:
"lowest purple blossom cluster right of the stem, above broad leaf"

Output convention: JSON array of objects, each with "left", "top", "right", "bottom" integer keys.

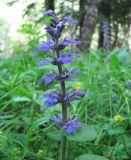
[{"left": 62, "top": 116, "right": 82, "bottom": 134}]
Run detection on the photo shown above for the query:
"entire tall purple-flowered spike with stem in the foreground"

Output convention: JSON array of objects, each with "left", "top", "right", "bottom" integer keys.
[{"left": 35, "top": 10, "right": 86, "bottom": 160}]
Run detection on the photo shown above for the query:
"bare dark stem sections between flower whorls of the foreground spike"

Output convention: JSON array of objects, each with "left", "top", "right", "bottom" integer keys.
[{"left": 56, "top": 40, "right": 67, "bottom": 160}]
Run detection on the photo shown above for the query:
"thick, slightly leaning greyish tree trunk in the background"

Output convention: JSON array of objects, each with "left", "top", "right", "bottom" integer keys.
[{"left": 81, "top": 0, "right": 100, "bottom": 49}]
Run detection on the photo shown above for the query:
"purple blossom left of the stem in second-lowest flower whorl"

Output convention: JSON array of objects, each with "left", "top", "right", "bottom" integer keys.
[{"left": 42, "top": 92, "right": 61, "bottom": 107}]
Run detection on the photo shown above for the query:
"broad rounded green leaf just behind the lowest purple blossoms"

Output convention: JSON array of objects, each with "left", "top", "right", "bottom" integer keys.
[{"left": 67, "top": 124, "right": 97, "bottom": 142}]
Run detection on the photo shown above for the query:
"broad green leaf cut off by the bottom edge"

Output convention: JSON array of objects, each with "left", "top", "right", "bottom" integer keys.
[{"left": 75, "top": 154, "right": 109, "bottom": 160}]
